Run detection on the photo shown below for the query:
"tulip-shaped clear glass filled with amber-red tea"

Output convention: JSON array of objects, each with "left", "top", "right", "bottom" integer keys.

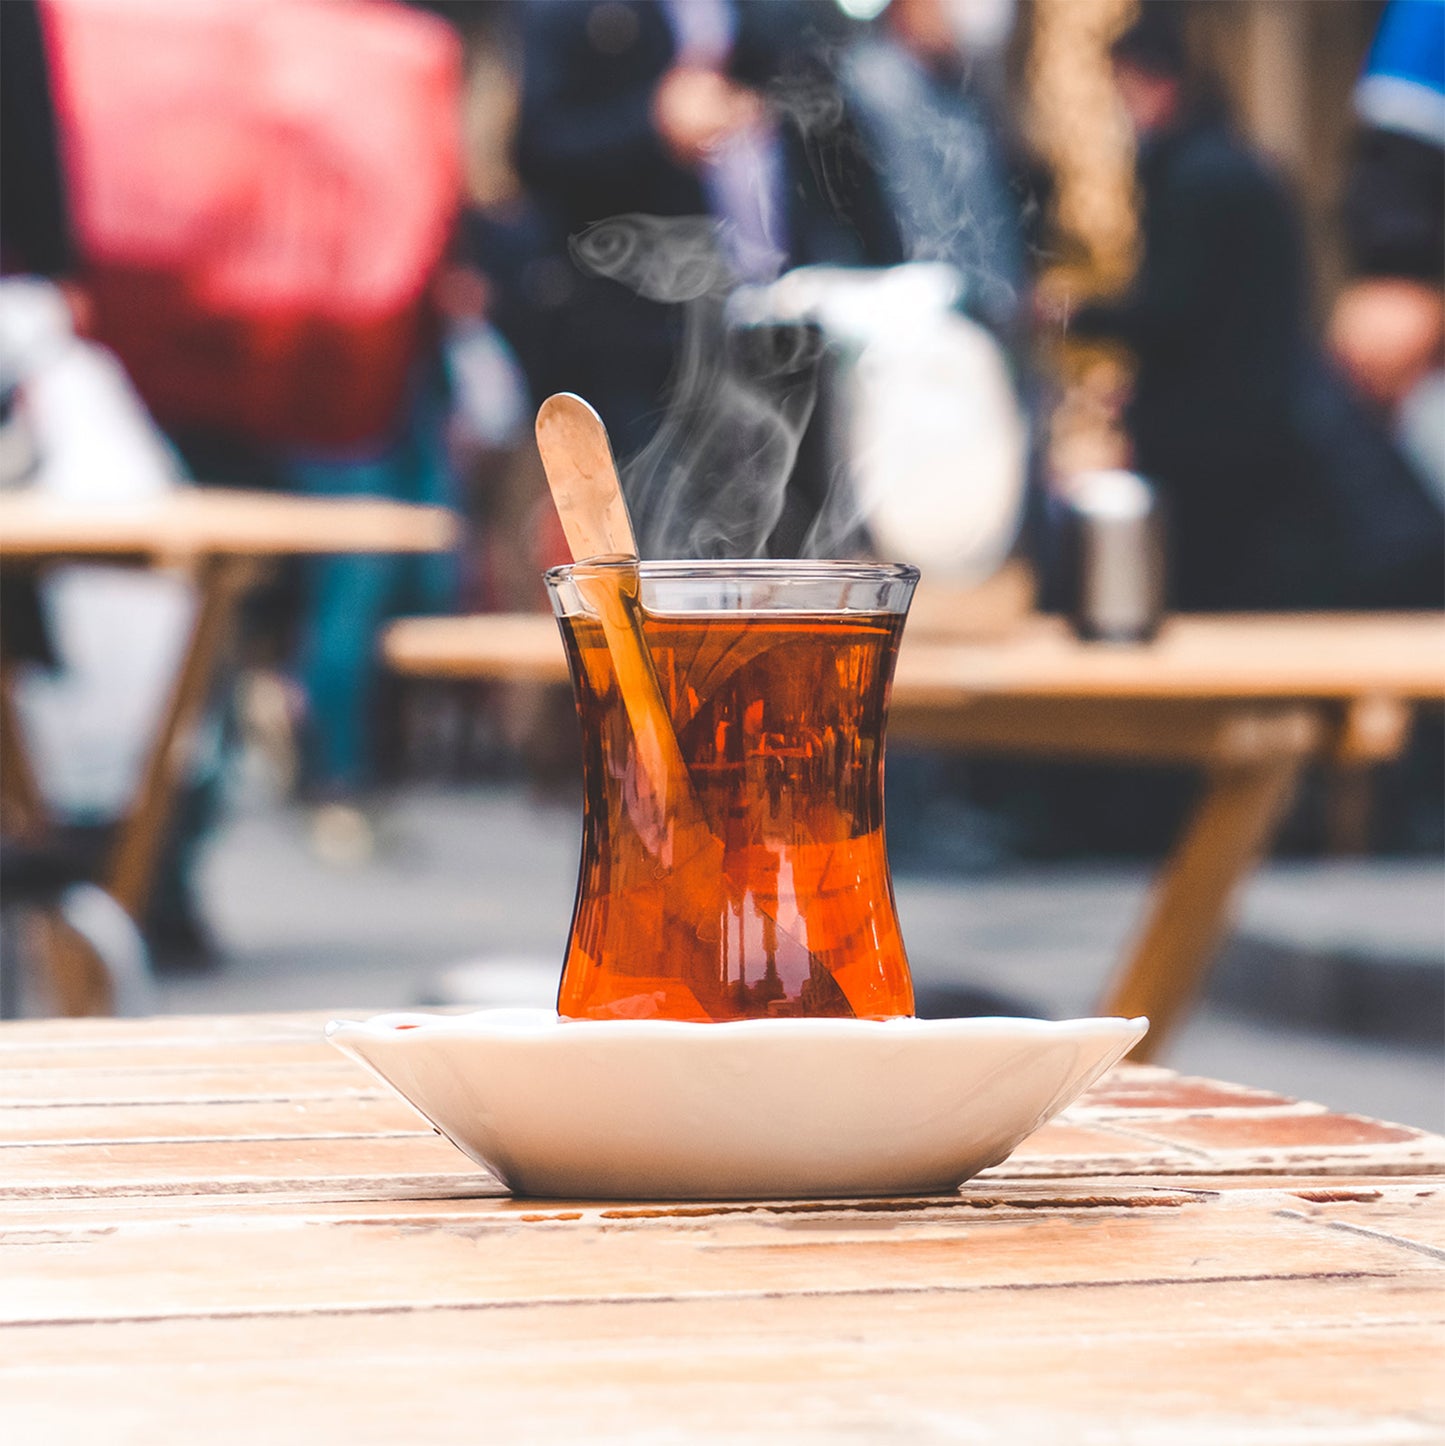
[{"left": 547, "top": 561, "right": 918, "bottom": 1019}]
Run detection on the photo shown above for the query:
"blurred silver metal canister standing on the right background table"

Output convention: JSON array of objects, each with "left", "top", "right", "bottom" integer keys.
[{"left": 1066, "top": 470, "right": 1164, "bottom": 642}]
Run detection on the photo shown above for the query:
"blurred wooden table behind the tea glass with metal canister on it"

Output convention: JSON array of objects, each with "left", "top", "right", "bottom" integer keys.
[{"left": 385, "top": 609, "right": 1445, "bottom": 1057}]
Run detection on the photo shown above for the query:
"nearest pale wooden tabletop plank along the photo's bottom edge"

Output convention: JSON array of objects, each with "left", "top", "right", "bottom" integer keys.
[{"left": 0, "top": 1272, "right": 1445, "bottom": 1446}]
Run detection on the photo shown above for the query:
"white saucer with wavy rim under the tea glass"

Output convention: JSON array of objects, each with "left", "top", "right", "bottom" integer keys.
[{"left": 327, "top": 1009, "right": 1148, "bottom": 1200}]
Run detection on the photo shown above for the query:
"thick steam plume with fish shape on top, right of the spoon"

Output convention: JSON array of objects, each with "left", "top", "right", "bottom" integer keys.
[{"left": 571, "top": 215, "right": 820, "bottom": 558}]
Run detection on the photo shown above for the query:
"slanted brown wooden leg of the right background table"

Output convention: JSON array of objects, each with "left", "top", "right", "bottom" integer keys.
[{"left": 1101, "top": 755, "right": 1303, "bottom": 1060}]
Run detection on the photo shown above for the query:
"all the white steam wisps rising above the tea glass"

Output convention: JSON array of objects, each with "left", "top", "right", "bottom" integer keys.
[{"left": 558, "top": 39, "right": 1023, "bottom": 558}]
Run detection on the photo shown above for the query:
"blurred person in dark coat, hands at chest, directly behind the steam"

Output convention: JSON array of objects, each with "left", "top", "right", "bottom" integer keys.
[{"left": 518, "top": 0, "right": 901, "bottom": 455}]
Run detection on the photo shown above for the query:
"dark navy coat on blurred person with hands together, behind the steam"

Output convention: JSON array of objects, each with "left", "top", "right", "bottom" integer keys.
[{"left": 516, "top": 0, "right": 903, "bottom": 454}]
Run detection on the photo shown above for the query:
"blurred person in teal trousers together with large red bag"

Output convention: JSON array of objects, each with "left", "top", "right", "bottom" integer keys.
[{"left": 0, "top": 0, "right": 460, "bottom": 960}]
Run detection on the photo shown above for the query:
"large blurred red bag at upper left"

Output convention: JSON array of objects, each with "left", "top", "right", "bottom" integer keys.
[{"left": 39, "top": 0, "right": 461, "bottom": 445}]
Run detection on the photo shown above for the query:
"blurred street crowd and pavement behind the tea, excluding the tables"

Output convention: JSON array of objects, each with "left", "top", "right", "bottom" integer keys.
[{"left": 0, "top": 0, "right": 1445, "bottom": 1128}]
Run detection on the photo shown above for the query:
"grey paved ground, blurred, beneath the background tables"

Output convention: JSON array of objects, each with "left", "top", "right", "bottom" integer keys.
[{"left": 141, "top": 787, "right": 1445, "bottom": 1129}]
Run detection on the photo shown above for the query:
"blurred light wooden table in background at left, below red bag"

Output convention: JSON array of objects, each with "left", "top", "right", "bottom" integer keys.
[{"left": 0, "top": 487, "right": 457, "bottom": 1008}]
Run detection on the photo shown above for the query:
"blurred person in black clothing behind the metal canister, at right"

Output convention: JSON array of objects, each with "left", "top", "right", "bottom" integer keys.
[{"left": 1072, "top": 0, "right": 1442, "bottom": 610}]
